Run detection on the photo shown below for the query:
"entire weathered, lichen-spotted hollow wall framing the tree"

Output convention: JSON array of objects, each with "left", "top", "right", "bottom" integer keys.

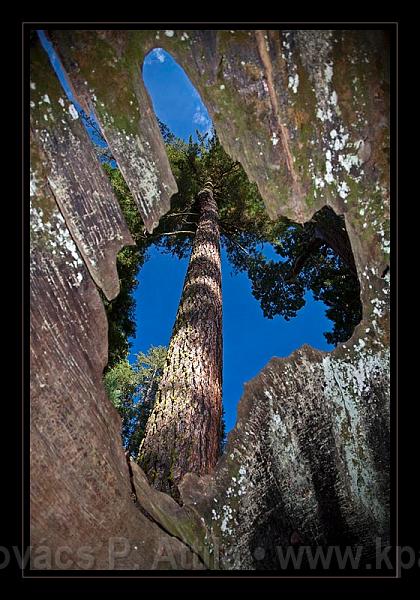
[{"left": 30, "top": 30, "right": 390, "bottom": 570}]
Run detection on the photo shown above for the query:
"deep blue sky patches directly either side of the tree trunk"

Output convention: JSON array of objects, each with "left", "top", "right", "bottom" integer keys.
[{"left": 132, "top": 248, "right": 332, "bottom": 431}]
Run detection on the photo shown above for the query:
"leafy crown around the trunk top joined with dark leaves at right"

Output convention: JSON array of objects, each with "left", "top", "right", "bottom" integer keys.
[{"left": 155, "top": 124, "right": 361, "bottom": 344}]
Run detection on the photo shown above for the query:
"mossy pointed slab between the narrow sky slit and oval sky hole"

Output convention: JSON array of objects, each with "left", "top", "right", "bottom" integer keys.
[{"left": 46, "top": 29, "right": 177, "bottom": 233}]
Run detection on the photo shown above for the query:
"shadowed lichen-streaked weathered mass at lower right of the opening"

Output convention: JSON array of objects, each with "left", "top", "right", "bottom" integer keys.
[{"left": 180, "top": 346, "right": 389, "bottom": 570}]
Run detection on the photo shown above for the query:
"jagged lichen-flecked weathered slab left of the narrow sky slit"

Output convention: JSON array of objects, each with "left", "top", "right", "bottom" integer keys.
[{"left": 30, "top": 34, "right": 134, "bottom": 299}]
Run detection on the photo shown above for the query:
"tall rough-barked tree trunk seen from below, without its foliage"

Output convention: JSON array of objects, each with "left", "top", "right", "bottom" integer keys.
[{"left": 139, "top": 183, "right": 222, "bottom": 499}]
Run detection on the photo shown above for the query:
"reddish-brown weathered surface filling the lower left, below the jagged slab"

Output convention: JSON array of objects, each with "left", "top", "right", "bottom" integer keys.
[{"left": 30, "top": 171, "right": 205, "bottom": 569}]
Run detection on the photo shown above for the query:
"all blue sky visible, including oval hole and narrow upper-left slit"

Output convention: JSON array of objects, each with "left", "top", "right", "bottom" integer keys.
[{"left": 36, "top": 33, "right": 333, "bottom": 431}]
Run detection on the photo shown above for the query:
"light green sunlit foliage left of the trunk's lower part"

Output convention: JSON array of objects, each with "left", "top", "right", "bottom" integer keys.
[{"left": 104, "top": 346, "right": 167, "bottom": 457}]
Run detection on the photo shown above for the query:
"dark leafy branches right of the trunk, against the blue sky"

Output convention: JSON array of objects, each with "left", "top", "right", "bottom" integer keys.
[{"left": 225, "top": 208, "right": 362, "bottom": 345}]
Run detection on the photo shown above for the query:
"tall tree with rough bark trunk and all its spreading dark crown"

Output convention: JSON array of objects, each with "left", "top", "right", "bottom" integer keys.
[{"left": 97, "top": 119, "right": 361, "bottom": 497}]
